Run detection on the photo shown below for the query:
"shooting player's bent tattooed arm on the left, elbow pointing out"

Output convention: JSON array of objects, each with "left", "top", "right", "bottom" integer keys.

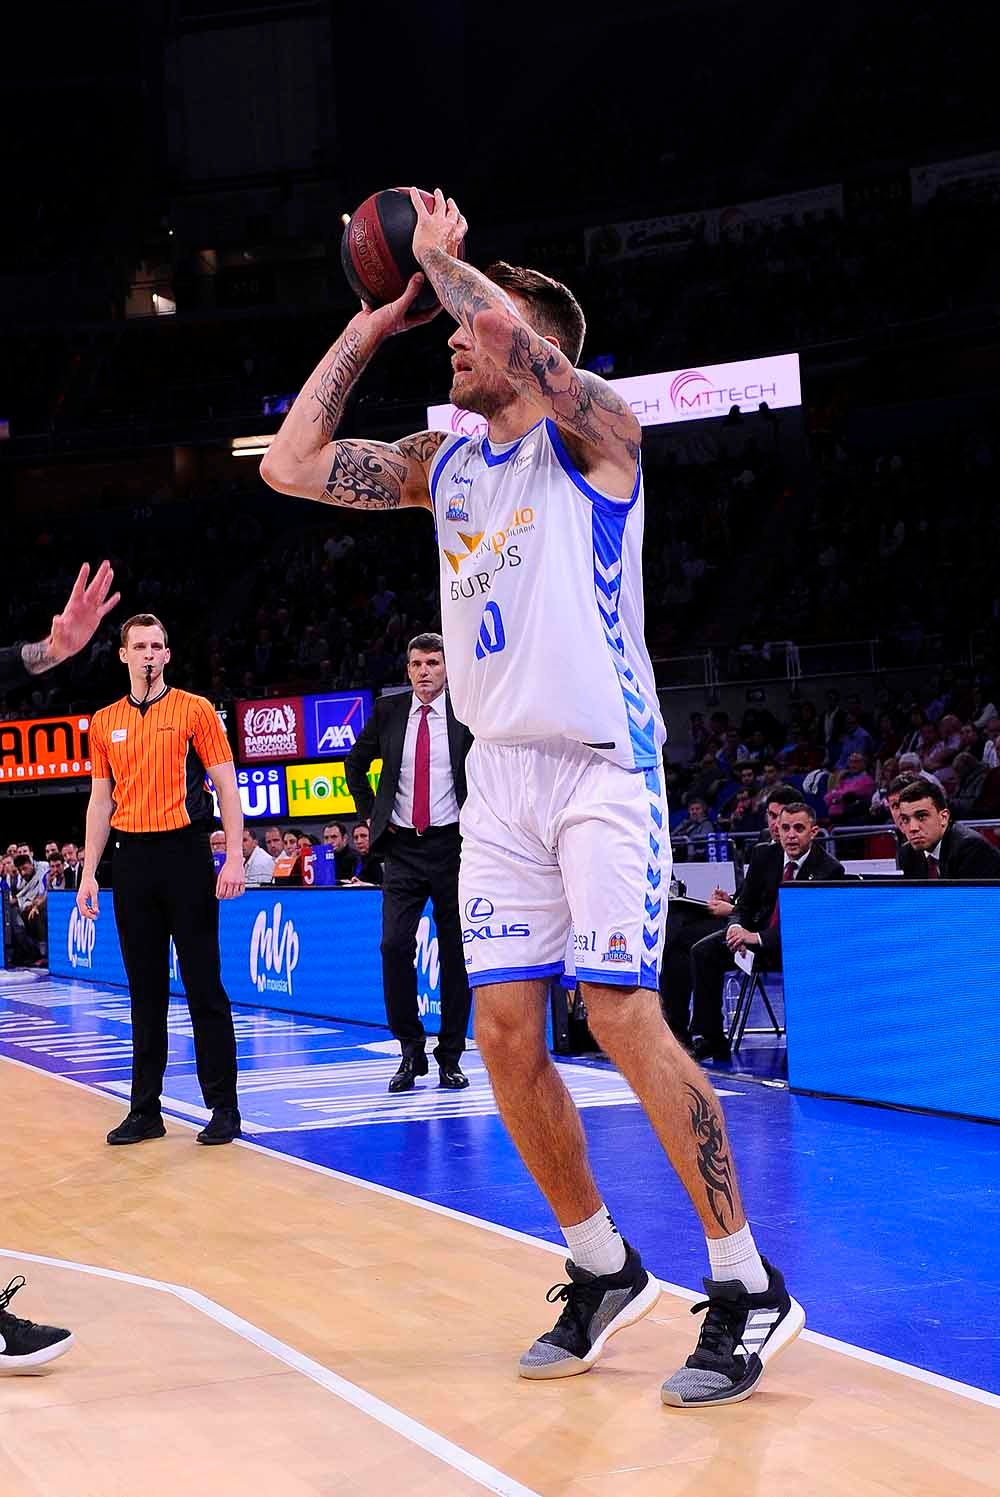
[{"left": 260, "top": 275, "right": 445, "bottom": 509}]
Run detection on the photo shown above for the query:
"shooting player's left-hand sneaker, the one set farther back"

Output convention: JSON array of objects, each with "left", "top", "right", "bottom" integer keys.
[{"left": 518, "top": 1243, "right": 660, "bottom": 1377}]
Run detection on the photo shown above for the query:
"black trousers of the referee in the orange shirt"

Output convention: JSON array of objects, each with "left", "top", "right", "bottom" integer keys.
[{"left": 111, "top": 828, "right": 237, "bottom": 1117}]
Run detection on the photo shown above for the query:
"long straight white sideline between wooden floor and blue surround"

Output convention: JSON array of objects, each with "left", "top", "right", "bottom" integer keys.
[{"left": 0, "top": 1054, "right": 1000, "bottom": 1409}]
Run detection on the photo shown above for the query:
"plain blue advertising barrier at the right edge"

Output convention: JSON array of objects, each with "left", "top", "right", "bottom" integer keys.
[{"left": 781, "top": 879, "right": 1000, "bottom": 1121}]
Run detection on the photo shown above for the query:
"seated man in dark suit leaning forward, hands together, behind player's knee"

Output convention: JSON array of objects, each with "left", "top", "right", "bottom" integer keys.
[{"left": 692, "top": 801, "right": 844, "bottom": 1060}]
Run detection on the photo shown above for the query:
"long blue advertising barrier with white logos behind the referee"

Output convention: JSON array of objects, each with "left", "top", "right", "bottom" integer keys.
[{"left": 48, "top": 889, "right": 442, "bottom": 1034}]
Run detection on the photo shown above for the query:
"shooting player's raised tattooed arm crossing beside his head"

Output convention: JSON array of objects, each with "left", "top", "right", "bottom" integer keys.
[{"left": 410, "top": 189, "right": 641, "bottom": 473}]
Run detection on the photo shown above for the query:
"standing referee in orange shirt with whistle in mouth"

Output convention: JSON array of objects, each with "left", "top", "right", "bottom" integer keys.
[{"left": 76, "top": 614, "right": 244, "bottom": 1144}]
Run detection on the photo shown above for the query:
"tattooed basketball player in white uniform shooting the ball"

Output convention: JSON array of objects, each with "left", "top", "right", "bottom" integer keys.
[{"left": 262, "top": 190, "right": 805, "bottom": 1407}]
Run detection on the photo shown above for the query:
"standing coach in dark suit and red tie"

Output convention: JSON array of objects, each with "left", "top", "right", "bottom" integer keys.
[{"left": 344, "top": 635, "right": 472, "bottom": 1091}]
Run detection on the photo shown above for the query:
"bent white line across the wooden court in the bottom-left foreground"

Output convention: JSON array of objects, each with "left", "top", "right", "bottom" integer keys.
[{"left": 0, "top": 1247, "right": 539, "bottom": 1497}]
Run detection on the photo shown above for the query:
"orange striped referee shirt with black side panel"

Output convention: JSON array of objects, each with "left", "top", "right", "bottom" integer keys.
[{"left": 90, "top": 686, "right": 232, "bottom": 832}]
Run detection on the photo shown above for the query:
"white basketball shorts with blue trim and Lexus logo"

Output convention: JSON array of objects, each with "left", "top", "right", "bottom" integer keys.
[{"left": 458, "top": 738, "right": 671, "bottom": 988}]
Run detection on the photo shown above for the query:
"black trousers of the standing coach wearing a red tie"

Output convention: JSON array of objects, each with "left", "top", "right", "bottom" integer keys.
[{"left": 382, "top": 823, "right": 472, "bottom": 1066}]
